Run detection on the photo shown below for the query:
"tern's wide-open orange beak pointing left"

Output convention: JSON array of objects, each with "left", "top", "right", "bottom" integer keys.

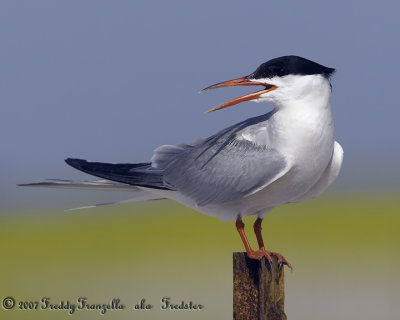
[{"left": 200, "top": 77, "right": 277, "bottom": 113}]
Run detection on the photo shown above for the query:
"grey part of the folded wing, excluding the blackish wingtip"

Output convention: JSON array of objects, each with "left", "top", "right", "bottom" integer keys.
[{"left": 152, "top": 116, "right": 287, "bottom": 206}]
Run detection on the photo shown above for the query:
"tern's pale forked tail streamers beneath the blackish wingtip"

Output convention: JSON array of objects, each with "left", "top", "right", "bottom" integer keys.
[{"left": 19, "top": 179, "right": 162, "bottom": 211}]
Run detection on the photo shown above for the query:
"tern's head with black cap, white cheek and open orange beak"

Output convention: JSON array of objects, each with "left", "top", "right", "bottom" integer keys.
[{"left": 201, "top": 56, "right": 335, "bottom": 113}]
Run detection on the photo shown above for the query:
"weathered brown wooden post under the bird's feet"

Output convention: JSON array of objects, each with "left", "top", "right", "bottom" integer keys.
[{"left": 233, "top": 252, "right": 286, "bottom": 320}]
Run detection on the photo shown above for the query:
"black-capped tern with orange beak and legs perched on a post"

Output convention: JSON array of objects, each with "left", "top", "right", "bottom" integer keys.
[{"left": 23, "top": 55, "right": 343, "bottom": 268}]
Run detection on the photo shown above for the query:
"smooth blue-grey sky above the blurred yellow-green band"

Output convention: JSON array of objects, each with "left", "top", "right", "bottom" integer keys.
[{"left": 0, "top": 0, "right": 400, "bottom": 208}]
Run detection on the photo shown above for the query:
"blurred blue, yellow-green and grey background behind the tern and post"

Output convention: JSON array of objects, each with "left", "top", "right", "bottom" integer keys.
[{"left": 0, "top": 0, "right": 400, "bottom": 320}]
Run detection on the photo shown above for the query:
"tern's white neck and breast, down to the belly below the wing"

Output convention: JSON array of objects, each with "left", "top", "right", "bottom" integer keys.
[{"left": 219, "top": 76, "right": 334, "bottom": 217}]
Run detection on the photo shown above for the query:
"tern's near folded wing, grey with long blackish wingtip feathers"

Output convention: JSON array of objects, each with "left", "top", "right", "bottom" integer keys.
[{"left": 61, "top": 114, "right": 288, "bottom": 206}]
